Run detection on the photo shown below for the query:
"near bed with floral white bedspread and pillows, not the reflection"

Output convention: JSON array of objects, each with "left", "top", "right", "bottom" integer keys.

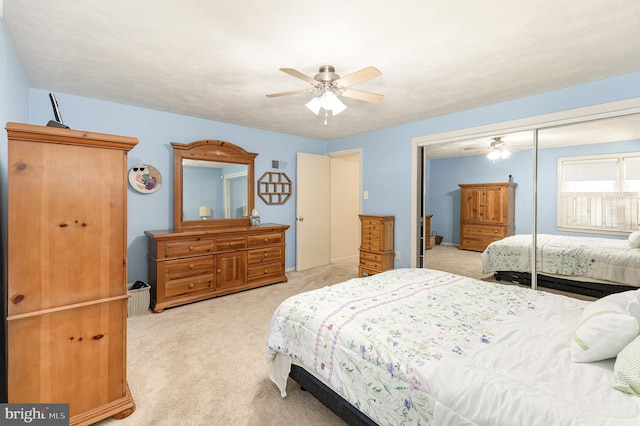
[{"left": 266, "top": 269, "right": 640, "bottom": 426}]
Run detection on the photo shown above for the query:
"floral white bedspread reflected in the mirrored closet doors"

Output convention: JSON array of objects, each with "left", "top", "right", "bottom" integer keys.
[{"left": 481, "top": 234, "right": 640, "bottom": 287}]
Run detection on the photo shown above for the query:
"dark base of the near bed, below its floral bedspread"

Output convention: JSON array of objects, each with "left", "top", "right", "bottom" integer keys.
[{"left": 289, "top": 365, "right": 378, "bottom": 426}]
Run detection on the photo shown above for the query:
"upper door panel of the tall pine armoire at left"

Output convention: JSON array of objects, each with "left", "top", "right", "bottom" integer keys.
[{"left": 8, "top": 141, "right": 126, "bottom": 315}]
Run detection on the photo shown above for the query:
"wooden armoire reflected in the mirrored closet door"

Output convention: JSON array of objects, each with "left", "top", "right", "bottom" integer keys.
[{"left": 459, "top": 182, "right": 517, "bottom": 251}]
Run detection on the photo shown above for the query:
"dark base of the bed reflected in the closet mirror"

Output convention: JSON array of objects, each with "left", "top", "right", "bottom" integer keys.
[{"left": 493, "top": 271, "right": 635, "bottom": 298}]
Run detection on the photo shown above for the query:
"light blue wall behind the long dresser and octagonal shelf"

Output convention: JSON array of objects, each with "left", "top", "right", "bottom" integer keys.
[{"left": 29, "top": 89, "right": 325, "bottom": 281}]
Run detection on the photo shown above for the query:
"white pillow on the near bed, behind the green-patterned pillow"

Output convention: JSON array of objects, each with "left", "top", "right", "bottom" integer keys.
[{"left": 571, "top": 290, "right": 640, "bottom": 362}]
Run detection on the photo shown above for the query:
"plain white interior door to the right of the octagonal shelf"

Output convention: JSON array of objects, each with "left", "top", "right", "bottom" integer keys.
[{"left": 296, "top": 152, "right": 330, "bottom": 271}]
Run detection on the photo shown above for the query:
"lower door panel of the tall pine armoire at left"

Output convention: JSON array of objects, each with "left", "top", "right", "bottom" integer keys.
[{"left": 7, "top": 299, "right": 127, "bottom": 416}]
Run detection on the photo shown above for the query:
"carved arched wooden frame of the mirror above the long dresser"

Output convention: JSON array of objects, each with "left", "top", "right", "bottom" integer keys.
[{"left": 171, "top": 139, "right": 258, "bottom": 231}]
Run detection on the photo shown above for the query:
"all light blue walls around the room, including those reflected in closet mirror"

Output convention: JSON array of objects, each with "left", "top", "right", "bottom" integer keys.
[{"left": 0, "top": 13, "right": 640, "bottom": 280}]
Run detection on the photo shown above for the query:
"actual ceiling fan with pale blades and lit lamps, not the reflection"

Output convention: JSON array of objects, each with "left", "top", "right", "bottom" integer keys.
[{"left": 267, "top": 65, "right": 384, "bottom": 124}]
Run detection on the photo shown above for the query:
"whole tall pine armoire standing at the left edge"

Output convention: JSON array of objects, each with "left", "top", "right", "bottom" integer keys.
[{"left": 6, "top": 123, "right": 138, "bottom": 425}]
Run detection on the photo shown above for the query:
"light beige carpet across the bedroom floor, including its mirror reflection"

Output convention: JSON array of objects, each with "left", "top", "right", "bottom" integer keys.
[{"left": 99, "top": 245, "right": 592, "bottom": 426}]
